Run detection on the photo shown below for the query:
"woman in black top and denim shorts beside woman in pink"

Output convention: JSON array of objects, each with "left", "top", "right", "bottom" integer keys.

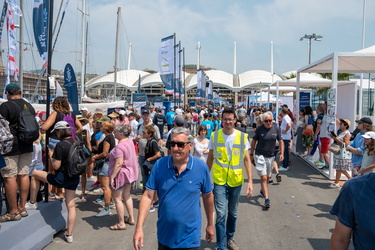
[{"left": 91, "top": 121, "right": 116, "bottom": 217}]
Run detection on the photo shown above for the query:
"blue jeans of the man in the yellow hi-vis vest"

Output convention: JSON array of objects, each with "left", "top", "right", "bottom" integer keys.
[{"left": 214, "top": 183, "right": 242, "bottom": 250}]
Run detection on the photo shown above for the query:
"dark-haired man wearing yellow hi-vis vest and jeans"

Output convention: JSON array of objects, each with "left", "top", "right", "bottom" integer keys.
[{"left": 207, "top": 108, "right": 253, "bottom": 250}]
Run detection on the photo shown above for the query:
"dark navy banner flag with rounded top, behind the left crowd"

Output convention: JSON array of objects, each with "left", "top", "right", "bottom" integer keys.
[{"left": 64, "top": 63, "right": 79, "bottom": 115}]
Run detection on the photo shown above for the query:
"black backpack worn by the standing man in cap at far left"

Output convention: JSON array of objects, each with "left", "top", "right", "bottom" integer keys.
[{"left": 13, "top": 102, "right": 39, "bottom": 144}]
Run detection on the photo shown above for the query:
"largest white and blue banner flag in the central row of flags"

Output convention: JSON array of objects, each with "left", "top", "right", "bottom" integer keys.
[{"left": 159, "top": 35, "right": 174, "bottom": 95}]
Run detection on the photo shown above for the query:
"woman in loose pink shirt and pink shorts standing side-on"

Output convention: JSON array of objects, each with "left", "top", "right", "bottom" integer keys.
[{"left": 108, "top": 124, "right": 138, "bottom": 230}]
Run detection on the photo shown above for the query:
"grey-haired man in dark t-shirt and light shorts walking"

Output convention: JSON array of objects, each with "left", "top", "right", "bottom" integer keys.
[{"left": 250, "top": 112, "right": 284, "bottom": 208}]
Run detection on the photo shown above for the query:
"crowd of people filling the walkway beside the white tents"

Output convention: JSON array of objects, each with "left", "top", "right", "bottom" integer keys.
[{"left": 0, "top": 84, "right": 375, "bottom": 249}]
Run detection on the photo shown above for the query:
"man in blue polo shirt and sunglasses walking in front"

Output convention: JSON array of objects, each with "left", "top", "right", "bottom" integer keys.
[{"left": 133, "top": 127, "right": 214, "bottom": 250}]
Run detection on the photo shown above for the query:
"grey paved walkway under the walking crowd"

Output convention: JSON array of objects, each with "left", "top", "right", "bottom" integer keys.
[{"left": 41, "top": 151, "right": 346, "bottom": 250}]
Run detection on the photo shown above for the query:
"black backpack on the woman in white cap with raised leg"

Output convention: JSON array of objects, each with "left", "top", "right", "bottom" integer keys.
[{"left": 63, "top": 140, "right": 89, "bottom": 178}]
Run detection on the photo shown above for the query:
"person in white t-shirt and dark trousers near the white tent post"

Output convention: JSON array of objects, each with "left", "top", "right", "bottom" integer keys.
[{"left": 279, "top": 109, "right": 292, "bottom": 171}]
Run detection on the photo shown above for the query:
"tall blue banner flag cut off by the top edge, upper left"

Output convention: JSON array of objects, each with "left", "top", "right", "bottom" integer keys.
[{"left": 33, "top": 0, "right": 49, "bottom": 69}]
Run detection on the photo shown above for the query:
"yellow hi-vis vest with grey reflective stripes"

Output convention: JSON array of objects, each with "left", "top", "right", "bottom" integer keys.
[{"left": 211, "top": 129, "right": 247, "bottom": 187}]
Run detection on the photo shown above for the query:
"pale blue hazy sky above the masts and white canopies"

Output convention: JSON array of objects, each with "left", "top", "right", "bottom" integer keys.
[{"left": 13, "top": 0, "right": 375, "bottom": 74}]
